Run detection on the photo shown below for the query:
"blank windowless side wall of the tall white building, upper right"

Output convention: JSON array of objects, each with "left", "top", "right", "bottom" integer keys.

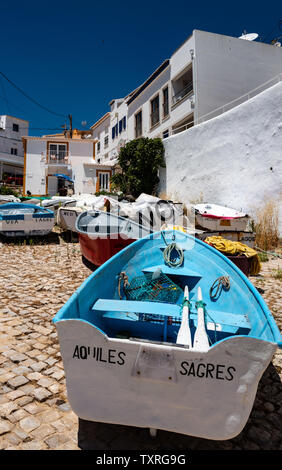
[{"left": 193, "top": 30, "right": 282, "bottom": 122}]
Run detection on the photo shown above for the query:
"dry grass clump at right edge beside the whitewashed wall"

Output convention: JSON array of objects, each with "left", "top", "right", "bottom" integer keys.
[{"left": 254, "top": 200, "right": 279, "bottom": 251}]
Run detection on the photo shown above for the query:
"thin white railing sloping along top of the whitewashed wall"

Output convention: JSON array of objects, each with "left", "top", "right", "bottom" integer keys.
[{"left": 172, "top": 73, "right": 282, "bottom": 134}]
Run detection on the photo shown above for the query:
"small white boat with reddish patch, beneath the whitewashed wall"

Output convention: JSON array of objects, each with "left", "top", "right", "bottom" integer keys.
[{"left": 192, "top": 204, "right": 249, "bottom": 232}]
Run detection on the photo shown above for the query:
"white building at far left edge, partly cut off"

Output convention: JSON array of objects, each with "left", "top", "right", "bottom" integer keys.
[{"left": 0, "top": 115, "right": 29, "bottom": 180}]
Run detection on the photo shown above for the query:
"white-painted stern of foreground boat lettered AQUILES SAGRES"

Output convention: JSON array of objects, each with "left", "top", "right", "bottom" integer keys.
[{"left": 56, "top": 320, "right": 277, "bottom": 440}]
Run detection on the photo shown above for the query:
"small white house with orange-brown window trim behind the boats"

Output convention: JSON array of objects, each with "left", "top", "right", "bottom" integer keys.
[{"left": 23, "top": 130, "right": 112, "bottom": 196}]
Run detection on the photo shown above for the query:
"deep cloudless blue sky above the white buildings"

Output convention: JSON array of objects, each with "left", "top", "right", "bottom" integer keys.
[{"left": 0, "top": 0, "right": 282, "bottom": 135}]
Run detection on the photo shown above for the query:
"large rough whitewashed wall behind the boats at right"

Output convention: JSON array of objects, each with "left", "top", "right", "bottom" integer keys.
[{"left": 160, "top": 82, "right": 282, "bottom": 232}]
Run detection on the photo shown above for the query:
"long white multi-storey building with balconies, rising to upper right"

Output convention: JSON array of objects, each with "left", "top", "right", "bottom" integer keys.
[{"left": 92, "top": 30, "right": 282, "bottom": 164}]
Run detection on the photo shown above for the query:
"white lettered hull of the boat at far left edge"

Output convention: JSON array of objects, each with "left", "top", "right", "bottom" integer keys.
[{"left": 0, "top": 218, "right": 54, "bottom": 237}]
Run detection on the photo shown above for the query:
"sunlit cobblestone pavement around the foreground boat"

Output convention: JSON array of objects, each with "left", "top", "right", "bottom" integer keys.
[{"left": 0, "top": 232, "right": 282, "bottom": 451}]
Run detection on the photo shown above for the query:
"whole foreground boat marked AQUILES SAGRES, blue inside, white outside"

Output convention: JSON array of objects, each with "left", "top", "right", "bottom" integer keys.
[{"left": 53, "top": 230, "right": 282, "bottom": 440}]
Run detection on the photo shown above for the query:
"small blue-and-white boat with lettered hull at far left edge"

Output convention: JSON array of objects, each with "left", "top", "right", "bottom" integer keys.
[{"left": 0, "top": 203, "right": 54, "bottom": 237}]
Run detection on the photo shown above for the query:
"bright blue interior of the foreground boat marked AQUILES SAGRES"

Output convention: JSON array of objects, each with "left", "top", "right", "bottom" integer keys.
[{"left": 54, "top": 231, "right": 276, "bottom": 346}]
